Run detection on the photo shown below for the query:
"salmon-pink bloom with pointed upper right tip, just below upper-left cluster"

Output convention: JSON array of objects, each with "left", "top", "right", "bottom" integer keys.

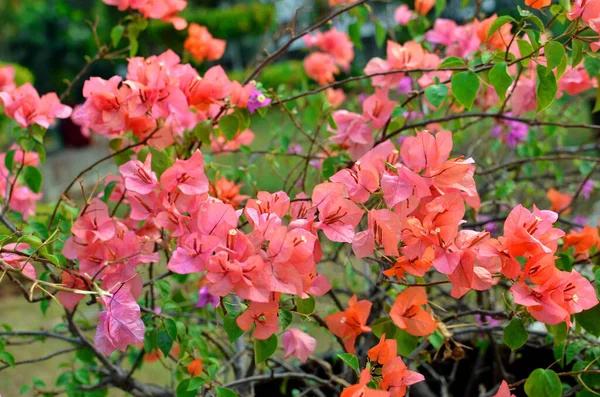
[{"left": 160, "top": 150, "right": 208, "bottom": 194}]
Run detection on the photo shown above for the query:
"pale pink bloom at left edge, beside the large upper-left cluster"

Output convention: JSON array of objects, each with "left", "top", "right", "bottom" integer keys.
[{"left": 0, "top": 83, "right": 73, "bottom": 128}]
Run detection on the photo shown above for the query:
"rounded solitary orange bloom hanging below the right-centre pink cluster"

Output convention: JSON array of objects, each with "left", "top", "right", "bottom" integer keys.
[{"left": 390, "top": 287, "right": 437, "bottom": 336}]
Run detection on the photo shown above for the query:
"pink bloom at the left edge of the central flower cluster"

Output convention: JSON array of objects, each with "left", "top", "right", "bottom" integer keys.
[{"left": 167, "top": 233, "right": 221, "bottom": 274}]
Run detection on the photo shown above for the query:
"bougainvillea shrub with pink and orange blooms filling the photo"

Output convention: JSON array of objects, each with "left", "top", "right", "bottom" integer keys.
[{"left": 0, "top": 0, "right": 600, "bottom": 397}]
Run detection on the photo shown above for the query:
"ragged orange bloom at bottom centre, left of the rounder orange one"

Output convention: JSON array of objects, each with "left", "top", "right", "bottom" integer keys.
[{"left": 325, "top": 295, "right": 372, "bottom": 353}]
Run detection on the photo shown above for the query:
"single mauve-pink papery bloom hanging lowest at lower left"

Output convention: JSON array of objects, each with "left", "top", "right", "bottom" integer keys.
[{"left": 94, "top": 291, "right": 145, "bottom": 355}]
